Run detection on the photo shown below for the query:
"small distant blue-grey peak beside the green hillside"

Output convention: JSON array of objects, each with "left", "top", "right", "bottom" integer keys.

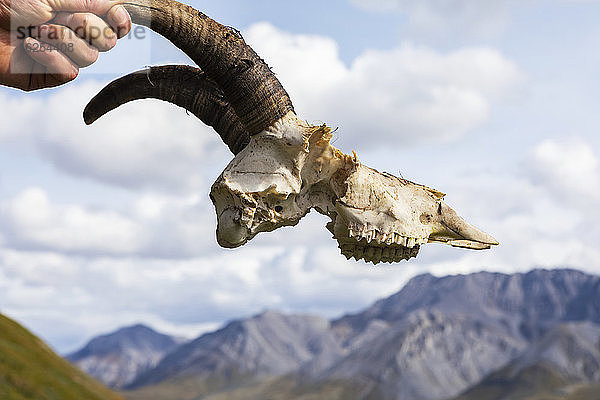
[{"left": 67, "top": 325, "right": 178, "bottom": 388}]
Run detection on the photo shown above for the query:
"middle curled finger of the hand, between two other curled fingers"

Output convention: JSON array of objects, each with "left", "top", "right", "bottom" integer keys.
[{"left": 32, "top": 24, "right": 98, "bottom": 68}]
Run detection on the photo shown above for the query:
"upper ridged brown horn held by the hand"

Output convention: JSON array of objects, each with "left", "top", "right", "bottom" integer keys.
[{"left": 123, "top": 0, "right": 294, "bottom": 135}]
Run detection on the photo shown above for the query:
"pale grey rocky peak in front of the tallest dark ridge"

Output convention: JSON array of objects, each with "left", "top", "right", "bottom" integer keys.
[{"left": 321, "top": 311, "right": 526, "bottom": 400}]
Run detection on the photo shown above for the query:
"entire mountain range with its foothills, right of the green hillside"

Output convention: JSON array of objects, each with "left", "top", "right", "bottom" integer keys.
[{"left": 69, "top": 270, "right": 600, "bottom": 400}]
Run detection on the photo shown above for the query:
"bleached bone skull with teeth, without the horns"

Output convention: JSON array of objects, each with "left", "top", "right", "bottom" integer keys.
[{"left": 211, "top": 114, "right": 496, "bottom": 264}]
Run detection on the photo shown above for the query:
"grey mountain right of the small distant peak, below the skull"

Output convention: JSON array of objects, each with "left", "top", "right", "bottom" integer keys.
[{"left": 132, "top": 311, "right": 342, "bottom": 387}]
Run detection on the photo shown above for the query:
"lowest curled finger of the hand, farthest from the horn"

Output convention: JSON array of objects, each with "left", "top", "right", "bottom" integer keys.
[{"left": 23, "top": 38, "right": 79, "bottom": 87}]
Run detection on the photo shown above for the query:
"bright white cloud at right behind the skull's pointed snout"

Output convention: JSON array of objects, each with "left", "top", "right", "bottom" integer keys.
[{"left": 412, "top": 138, "right": 600, "bottom": 273}]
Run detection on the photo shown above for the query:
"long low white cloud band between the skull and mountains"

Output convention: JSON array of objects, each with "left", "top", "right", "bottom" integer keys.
[{"left": 0, "top": 239, "right": 420, "bottom": 352}]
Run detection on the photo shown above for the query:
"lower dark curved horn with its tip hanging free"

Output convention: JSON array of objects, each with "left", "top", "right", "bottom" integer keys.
[{"left": 83, "top": 65, "right": 250, "bottom": 154}]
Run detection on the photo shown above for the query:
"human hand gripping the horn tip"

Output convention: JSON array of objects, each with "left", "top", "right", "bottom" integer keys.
[{"left": 0, "top": 0, "right": 131, "bottom": 91}]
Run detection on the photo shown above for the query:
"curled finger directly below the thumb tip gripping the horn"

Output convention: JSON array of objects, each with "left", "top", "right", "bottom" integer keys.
[{"left": 52, "top": 12, "right": 117, "bottom": 51}]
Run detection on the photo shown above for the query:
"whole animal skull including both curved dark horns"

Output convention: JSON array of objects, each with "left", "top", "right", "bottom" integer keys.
[{"left": 84, "top": 0, "right": 498, "bottom": 264}]
